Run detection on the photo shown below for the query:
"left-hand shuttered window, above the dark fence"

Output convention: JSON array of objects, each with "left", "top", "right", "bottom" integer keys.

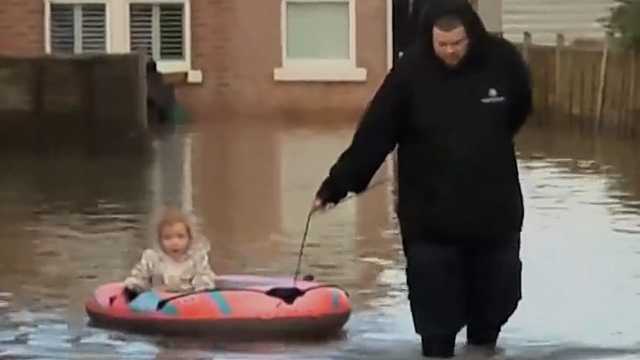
[{"left": 47, "top": 1, "right": 107, "bottom": 54}]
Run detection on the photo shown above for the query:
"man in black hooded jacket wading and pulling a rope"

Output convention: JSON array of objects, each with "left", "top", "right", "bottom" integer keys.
[{"left": 312, "top": 0, "right": 532, "bottom": 358}]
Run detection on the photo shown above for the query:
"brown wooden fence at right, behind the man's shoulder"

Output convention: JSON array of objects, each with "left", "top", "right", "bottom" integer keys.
[{"left": 520, "top": 33, "right": 640, "bottom": 136}]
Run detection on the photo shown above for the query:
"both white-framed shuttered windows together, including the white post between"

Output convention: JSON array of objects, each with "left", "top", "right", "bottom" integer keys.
[{"left": 45, "top": 0, "right": 196, "bottom": 76}]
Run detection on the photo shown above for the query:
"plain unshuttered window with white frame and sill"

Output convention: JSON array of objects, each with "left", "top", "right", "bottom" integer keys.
[{"left": 274, "top": 0, "right": 366, "bottom": 81}]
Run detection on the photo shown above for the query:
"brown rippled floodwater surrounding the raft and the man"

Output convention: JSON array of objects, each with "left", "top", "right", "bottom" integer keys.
[{"left": 0, "top": 119, "right": 640, "bottom": 360}]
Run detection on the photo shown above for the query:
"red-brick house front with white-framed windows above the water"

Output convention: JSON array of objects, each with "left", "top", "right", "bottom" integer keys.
[{"left": 0, "top": 0, "right": 484, "bottom": 115}]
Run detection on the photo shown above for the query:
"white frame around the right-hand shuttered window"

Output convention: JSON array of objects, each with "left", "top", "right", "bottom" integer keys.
[{"left": 121, "top": 0, "right": 191, "bottom": 73}]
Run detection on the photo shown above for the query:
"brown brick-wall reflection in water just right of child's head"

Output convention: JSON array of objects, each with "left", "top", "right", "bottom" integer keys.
[{"left": 192, "top": 119, "right": 281, "bottom": 272}]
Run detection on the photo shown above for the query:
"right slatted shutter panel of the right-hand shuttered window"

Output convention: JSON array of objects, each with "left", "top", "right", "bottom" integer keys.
[{"left": 160, "top": 4, "right": 184, "bottom": 60}]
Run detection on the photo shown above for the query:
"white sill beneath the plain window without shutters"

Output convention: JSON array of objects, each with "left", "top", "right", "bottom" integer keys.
[{"left": 273, "top": 66, "right": 367, "bottom": 82}]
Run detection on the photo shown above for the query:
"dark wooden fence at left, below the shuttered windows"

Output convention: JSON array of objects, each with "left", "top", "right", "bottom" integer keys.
[{"left": 0, "top": 54, "right": 147, "bottom": 148}]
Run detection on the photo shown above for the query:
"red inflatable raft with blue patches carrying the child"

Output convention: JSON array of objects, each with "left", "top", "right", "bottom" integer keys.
[{"left": 86, "top": 275, "right": 351, "bottom": 338}]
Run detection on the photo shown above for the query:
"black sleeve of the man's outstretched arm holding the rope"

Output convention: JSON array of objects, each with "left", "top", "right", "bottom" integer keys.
[{"left": 316, "top": 68, "right": 408, "bottom": 203}]
